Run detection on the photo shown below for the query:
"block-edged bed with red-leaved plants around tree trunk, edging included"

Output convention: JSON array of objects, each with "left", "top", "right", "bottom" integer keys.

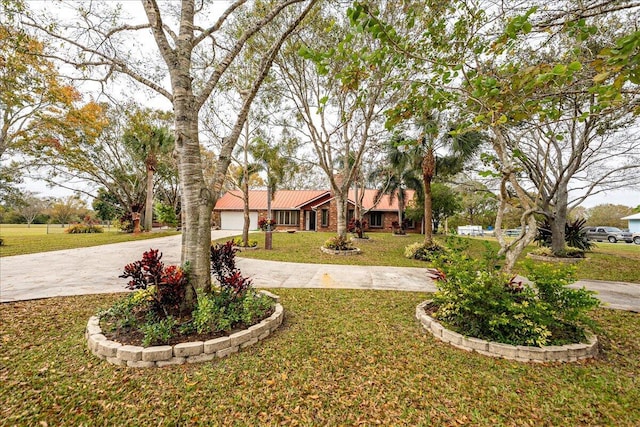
[{"left": 87, "top": 241, "right": 283, "bottom": 367}]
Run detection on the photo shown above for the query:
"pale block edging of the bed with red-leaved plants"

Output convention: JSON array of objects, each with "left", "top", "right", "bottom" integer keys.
[{"left": 85, "top": 291, "right": 284, "bottom": 368}]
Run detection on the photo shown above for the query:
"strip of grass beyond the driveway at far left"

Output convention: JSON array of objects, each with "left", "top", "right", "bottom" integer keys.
[{"left": 0, "top": 224, "right": 177, "bottom": 257}]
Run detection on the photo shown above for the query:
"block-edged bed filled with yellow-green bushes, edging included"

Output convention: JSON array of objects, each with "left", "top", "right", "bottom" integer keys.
[{"left": 416, "top": 236, "right": 600, "bottom": 361}]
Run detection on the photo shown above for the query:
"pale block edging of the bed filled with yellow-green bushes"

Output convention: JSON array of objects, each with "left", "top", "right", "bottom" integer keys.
[{"left": 416, "top": 300, "right": 598, "bottom": 363}]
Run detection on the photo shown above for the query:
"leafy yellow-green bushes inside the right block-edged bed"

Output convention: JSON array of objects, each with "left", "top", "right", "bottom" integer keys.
[{"left": 430, "top": 252, "right": 600, "bottom": 346}]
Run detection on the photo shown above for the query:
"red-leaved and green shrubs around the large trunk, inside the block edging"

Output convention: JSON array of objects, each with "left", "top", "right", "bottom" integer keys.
[{"left": 98, "top": 246, "right": 274, "bottom": 347}]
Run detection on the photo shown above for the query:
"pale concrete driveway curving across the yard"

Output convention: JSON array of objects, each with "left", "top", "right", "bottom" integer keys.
[{"left": 0, "top": 231, "right": 640, "bottom": 312}]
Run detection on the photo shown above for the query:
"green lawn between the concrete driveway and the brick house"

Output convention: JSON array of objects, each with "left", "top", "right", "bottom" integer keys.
[{"left": 221, "top": 233, "right": 640, "bottom": 283}]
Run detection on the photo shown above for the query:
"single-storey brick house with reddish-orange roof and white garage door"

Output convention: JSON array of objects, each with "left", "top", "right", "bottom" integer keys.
[{"left": 212, "top": 189, "right": 420, "bottom": 232}]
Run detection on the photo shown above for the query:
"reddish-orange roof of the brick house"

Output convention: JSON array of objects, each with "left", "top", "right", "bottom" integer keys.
[{"left": 214, "top": 189, "right": 414, "bottom": 211}]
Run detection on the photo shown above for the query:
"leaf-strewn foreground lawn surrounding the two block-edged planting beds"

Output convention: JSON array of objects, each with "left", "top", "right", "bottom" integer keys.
[{"left": 0, "top": 289, "right": 640, "bottom": 426}]
